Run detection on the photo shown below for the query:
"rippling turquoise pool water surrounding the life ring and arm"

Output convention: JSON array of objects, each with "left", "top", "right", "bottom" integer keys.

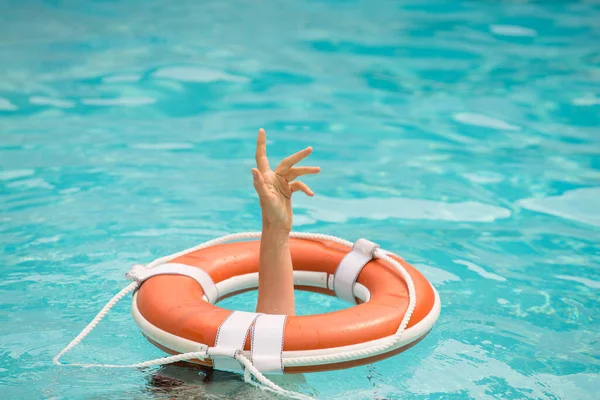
[{"left": 0, "top": 0, "right": 600, "bottom": 399}]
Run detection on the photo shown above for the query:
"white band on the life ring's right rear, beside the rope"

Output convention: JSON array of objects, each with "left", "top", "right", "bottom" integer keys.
[{"left": 333, "top": 239, "right": 379, "bottom": 304}]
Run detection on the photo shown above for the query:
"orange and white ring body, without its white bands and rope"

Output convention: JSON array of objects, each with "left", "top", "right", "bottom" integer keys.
[{"left": 132, "top": 238, "right": 440, "bottom": 373}]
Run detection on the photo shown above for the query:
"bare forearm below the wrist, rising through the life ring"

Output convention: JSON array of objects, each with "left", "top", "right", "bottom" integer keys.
[{"left": 256, "top": 221, "right": 295, "bottom": 315}]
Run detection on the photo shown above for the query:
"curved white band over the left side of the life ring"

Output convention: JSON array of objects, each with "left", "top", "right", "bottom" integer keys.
[{"left": 125, "top": 263, "right": 219, "bottom": 304}]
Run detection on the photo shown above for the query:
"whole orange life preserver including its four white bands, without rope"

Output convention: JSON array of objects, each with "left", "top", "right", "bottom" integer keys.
[{"left": 130, "top": 234, "right": 440, "bottom": 373}]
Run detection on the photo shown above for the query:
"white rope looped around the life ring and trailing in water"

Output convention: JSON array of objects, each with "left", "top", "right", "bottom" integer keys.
[{"left": 52, "top": 232, "right": 417, "bottom": 400}]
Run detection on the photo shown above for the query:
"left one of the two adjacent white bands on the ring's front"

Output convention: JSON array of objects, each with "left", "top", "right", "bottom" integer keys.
[{"left": 207, "top": 311, "right": 260, "bottom": 372}]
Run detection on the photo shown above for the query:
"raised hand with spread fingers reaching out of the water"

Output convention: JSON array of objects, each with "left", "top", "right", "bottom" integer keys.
[{"left": 252, "top": 129, "right": 321, "bottom": 232}]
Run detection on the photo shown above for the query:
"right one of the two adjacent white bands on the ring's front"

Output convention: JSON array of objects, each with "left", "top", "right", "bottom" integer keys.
[{"left": 251, "top": 314, "right": 286, "bottom": 374}]
